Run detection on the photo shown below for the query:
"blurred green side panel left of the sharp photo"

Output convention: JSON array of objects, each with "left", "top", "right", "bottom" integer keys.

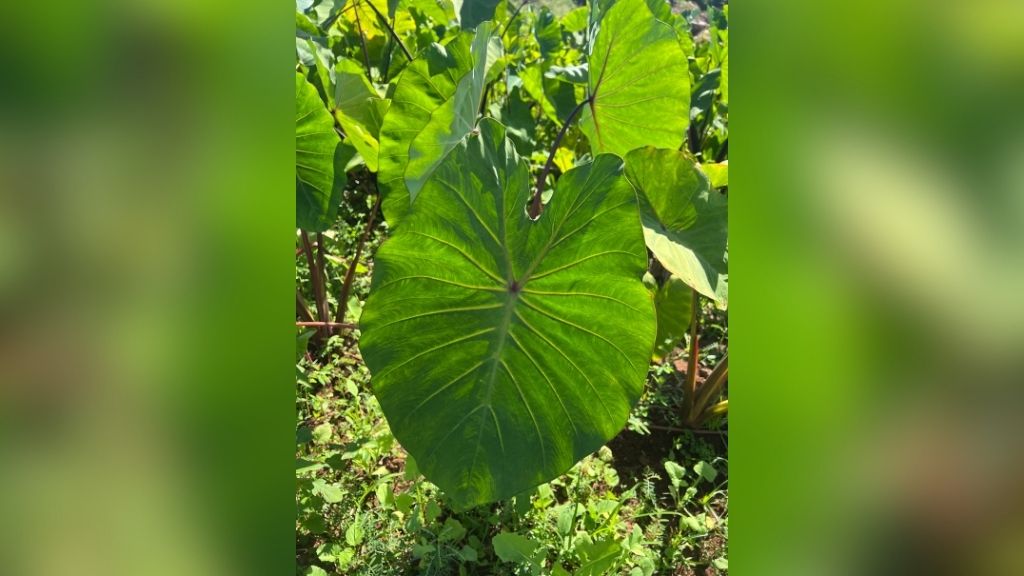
[{"left": 0, "top": 0, "right": 295, "bottom": 575}]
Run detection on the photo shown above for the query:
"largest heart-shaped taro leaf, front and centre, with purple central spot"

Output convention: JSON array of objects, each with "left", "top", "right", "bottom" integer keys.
[{"left": 359, "top": 119, "right": 655, "bottom": 506}]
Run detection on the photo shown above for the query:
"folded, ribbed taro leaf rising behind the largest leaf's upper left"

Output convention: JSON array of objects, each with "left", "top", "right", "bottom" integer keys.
[{"left": 379, "top": 23, "right": 502, "bottom": 228}]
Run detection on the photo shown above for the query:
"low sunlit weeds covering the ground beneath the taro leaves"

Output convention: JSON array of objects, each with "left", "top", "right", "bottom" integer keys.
[{"left": 296, "top": 216, "right": 729, "bottom": 576}]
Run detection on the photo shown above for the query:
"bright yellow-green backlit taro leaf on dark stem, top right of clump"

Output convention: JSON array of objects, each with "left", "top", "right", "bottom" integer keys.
[{"left": 581, "top": 0, "right": 690, "bottom": 156}]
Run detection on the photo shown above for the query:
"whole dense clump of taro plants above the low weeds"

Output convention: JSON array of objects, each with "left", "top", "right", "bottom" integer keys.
[{"left": 296, "top": 0, "right": 728, "bottom": 507}]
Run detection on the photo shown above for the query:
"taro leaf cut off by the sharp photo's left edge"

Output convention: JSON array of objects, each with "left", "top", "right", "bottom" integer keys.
[{"left": 295, "top": 73, "right": 345, "bottom": 232}]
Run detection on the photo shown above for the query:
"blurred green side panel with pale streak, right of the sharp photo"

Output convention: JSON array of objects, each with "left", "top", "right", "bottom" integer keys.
[{"left": 730, "top": 0, "right": 1024, "bottom": 576}]
